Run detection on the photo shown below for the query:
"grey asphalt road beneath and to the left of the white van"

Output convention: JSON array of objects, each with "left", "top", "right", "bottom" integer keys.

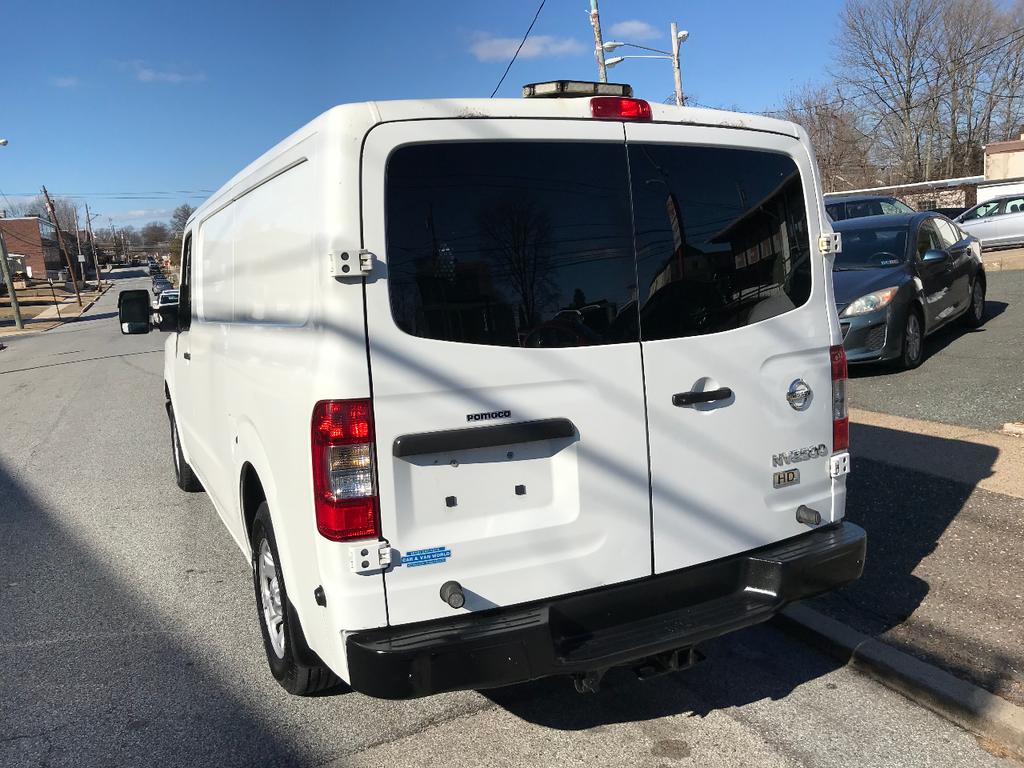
[{"left": 0, "top": 274, "right": 1012, "bottom": 768}]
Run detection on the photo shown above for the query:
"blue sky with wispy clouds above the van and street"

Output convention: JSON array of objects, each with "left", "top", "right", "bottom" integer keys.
[{"left": 0, "top": 0, "right": 842, "bottom": 226}]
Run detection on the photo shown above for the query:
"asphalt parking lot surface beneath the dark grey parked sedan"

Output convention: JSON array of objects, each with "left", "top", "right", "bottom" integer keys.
[{"left": 850, "top": 270, "right": 1024, "bottom": 429}]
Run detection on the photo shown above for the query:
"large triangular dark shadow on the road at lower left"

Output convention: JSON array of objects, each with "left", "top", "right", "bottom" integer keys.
[{"left": 0, "top": 463, "right": 294, "bottom": 766}]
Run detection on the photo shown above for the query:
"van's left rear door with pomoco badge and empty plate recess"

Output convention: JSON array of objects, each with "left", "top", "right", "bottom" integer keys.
[{"left": 362, "top": 120, "right": 651, "bottom": 624}]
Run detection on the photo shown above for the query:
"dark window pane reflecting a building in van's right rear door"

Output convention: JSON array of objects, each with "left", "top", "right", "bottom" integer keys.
[{"left": 629, "top": 144, "right": 811, "bottom": 341}]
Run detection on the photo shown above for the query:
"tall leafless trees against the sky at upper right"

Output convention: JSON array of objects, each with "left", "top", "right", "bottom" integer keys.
[{"left": 835, "top": 0, "right": 1024, "bottom": 183}]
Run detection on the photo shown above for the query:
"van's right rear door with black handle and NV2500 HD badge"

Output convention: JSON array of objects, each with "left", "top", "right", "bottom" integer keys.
[{"left": 626, "top": 124, "right": 834, "bottom": 572}]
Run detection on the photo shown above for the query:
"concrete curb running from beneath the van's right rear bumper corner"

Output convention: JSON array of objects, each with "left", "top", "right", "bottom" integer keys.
[{"left": 775, "top": 605, "right": 1024, "bottom": 760}]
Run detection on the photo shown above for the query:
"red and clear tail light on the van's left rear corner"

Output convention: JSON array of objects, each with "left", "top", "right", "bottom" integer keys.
[{"left": 310, "top": 399, "right": 380, "bottom": 542}]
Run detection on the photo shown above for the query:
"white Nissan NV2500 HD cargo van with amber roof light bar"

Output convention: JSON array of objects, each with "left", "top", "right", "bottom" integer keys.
[{"left": 120, "top": 81, "right": 865, "bottom": 697}]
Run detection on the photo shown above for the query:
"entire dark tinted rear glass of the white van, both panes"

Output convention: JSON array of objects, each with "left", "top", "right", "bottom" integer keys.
[{"left": 385, "top": 141, "right": 811, "bottom": 347}]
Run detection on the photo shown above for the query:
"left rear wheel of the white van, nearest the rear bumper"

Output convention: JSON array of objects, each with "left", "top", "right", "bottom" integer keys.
[{"left": 252, "top": 502, "right": 341, "bottom": 696}]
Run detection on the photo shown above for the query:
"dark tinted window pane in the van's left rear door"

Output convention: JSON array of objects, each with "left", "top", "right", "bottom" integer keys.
[{"left": 385, "top": 141, "right": 639, "bottom": 347}]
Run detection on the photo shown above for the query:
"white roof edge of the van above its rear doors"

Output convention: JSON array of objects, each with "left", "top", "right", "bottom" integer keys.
[{"left": 188, "top": 97, "right": 802, "bottom": 225}]
